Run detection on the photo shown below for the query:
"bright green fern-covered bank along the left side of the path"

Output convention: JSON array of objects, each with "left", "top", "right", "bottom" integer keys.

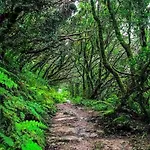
[{"left": 0, "top": 67, "right": 66, "bottom": 150}]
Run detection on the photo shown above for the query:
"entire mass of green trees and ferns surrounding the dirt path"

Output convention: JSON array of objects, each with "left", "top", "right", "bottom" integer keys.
[{"left": 0, "top": 0, "right": 150, "bottom": 150}]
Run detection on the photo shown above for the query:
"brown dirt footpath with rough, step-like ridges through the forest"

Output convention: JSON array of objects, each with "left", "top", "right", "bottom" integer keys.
[{"left": 46, "top": 103, "right": 132, "bottom": 150}]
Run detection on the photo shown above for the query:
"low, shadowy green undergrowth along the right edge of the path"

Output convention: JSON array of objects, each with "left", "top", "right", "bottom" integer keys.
[{"left": 72, "top": 95, "right": 149, "bottom": 135}]
